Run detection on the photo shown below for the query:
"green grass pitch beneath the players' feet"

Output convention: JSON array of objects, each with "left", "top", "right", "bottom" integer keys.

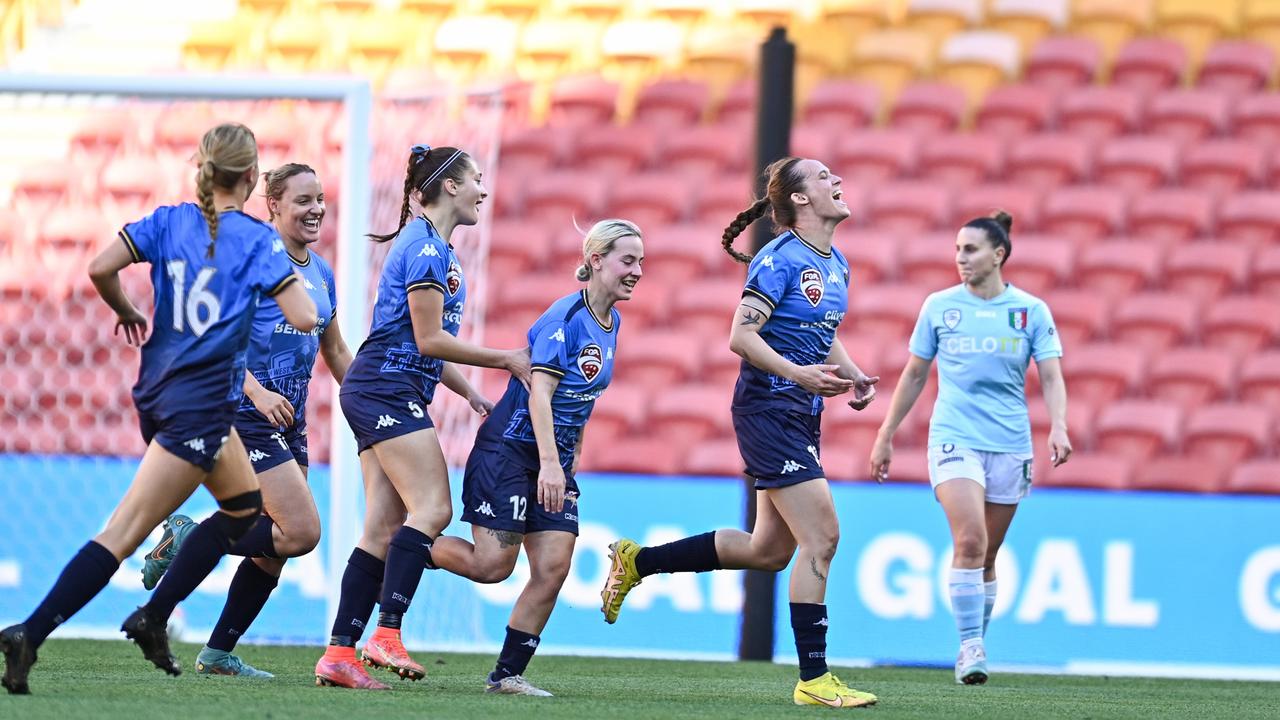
[{"left": 0, "top": 639, "right": 1280, "bottom": 720}]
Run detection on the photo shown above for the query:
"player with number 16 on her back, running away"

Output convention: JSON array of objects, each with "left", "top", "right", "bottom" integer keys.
[{"left": 0, "top": 124, "right": 316, "bottom": 693}]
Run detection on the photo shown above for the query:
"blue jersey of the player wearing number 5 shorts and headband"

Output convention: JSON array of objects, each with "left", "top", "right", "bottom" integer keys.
[{"left": 343, "top": 218, "right": 467, "bottom": 402}]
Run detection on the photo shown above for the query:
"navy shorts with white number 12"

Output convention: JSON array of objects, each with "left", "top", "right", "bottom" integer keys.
[{"left": 462, "top": 441, "right": 579, "bottom": 536}]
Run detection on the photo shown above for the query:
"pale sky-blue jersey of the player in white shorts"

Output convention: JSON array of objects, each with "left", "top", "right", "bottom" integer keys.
[{"left": 909, "top": 284, "right": 1062, "bottom": 452}]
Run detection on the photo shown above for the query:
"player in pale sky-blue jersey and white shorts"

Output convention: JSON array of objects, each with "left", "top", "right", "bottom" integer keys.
[{"left": 870, "top": 213, "right": 1071, "bottom": 685}]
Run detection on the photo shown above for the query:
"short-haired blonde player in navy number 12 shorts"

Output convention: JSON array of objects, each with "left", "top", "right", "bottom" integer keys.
[{"left": 431, "top": 219, "right": 644, "bottom": 697}]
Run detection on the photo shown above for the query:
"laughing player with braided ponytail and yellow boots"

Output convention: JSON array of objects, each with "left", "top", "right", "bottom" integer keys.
[{"left": 600, "top": 158, "right": 879, "bottom": 707}]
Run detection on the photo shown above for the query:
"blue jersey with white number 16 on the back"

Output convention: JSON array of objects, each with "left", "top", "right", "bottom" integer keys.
[{"left": 120, "top": 202, "right": 297, "bottom": 413}]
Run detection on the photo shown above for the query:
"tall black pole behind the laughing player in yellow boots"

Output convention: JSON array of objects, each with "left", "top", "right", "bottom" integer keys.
[{"left": 737, "top": 27, "right": 796, "bottom": 661}]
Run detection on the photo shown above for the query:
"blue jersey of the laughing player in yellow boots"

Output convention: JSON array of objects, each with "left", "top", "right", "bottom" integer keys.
[{"left": 733, "top": 232, "right": 849, "bottom": 415}]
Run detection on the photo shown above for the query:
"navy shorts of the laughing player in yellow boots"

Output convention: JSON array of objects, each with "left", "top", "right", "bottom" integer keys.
[{"left": 733, "top": 410, "right": 827, "bottom": 489}]
